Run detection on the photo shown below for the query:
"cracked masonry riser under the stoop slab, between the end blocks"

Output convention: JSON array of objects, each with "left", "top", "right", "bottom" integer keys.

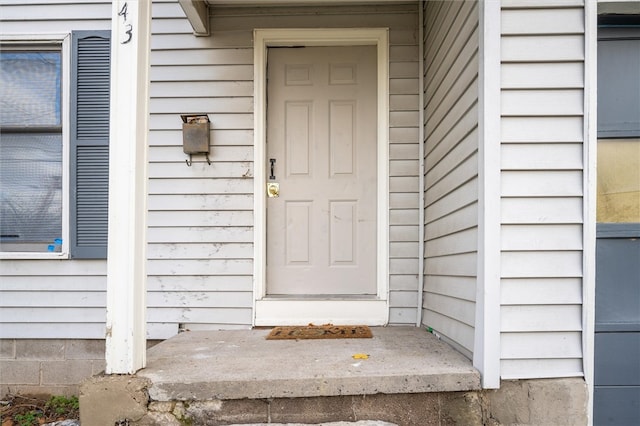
[{"left": 138, "top": 393, "right": 482, "bottom": 426}]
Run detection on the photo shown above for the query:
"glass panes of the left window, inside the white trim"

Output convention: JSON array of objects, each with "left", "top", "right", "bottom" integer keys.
[{"left": 0, "top": 50, "right": 62, "bottom": 252}]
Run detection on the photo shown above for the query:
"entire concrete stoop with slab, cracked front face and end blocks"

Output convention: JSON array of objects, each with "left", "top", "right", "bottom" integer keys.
[{"left": 79, "top": 327, "right": 587, "bottom": 426}]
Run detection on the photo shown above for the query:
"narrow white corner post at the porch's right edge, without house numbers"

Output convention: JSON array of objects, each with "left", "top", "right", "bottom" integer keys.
[{"left": 473, "top": 0, "right": 501, "bottom": 389}]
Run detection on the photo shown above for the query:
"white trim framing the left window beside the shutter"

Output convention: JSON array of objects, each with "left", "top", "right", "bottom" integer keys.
[{"left": 0, "top": 33, "right": 71, "bottom": 259}]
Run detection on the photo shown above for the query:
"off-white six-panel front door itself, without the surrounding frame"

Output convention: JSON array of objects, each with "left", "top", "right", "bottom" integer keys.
[{"left": 266, "top": 46, "right": 377, "bottom": 299}]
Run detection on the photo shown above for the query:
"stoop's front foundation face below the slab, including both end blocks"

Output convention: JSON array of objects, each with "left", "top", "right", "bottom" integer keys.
[{"left": 80, "top": 376, "right": 588, "bottom": 426}]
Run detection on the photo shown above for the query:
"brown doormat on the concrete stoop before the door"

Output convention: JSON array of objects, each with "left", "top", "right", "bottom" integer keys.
[{"left": 267, "top": 324, "right": 373, "bottom": 340}]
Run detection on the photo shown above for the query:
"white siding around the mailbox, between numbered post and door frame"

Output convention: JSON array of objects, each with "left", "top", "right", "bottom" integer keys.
[{"left": 147, "top": 2, "right": 253, "bottom": 337}]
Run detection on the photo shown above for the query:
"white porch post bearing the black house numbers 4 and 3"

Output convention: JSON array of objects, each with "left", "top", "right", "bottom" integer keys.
[{"left": 105, "top": 0, "right": 151, "bottom": 374}]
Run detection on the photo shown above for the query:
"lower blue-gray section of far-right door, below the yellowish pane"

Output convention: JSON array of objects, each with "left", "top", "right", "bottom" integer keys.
[{"left": 594, "top": 228, "right": 640, "bottom": 426}]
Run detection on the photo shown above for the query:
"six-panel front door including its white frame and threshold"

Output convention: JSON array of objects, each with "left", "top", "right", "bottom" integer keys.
[{"left": 254, "top": 28, "right": 389, "bottom": 326}]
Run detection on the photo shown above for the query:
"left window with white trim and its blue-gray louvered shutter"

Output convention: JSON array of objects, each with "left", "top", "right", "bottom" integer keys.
[{"left": 0, "top": 31, "right": 110, "bottom": 258}]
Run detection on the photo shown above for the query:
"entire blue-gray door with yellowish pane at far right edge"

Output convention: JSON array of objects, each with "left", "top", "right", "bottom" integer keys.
[{"left": 594, "top": 24, "right": 640, "bottom": 426}]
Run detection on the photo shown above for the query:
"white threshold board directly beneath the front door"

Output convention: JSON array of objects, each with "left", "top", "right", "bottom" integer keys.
[{"left": 254, "top": 298, "right": 389, "bottom": 326}]
